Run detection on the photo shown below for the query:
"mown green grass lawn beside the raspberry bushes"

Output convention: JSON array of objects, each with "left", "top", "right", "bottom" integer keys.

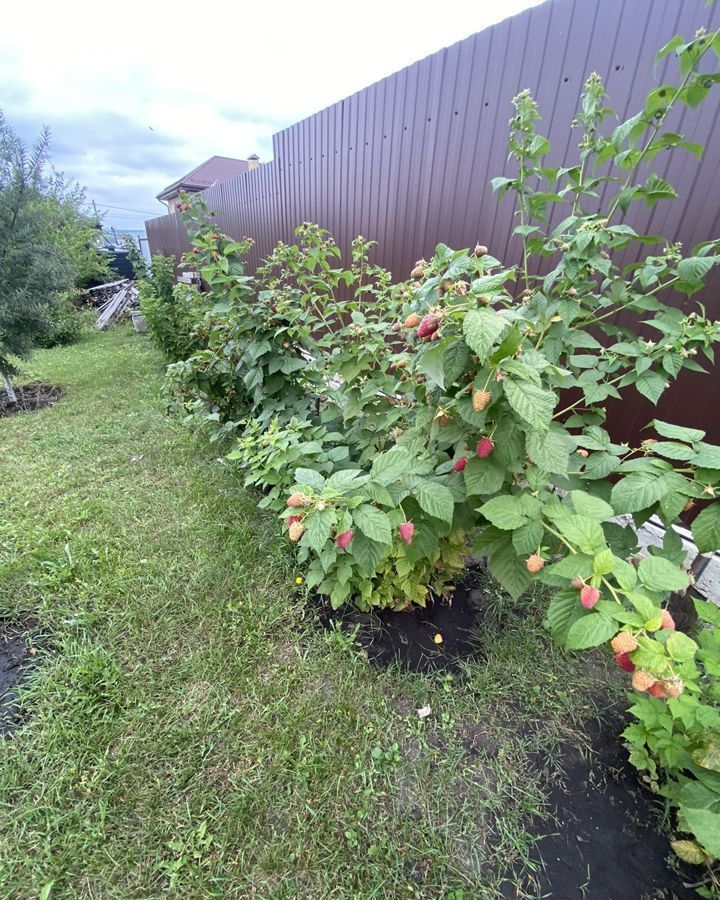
[{"left": 0, "top": 328, "right": 613, "bottom": 900}]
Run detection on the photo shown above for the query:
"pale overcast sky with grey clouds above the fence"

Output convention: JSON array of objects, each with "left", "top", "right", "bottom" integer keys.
[{"left": 0, "top": 0, "right": 540, "bottom": 228}]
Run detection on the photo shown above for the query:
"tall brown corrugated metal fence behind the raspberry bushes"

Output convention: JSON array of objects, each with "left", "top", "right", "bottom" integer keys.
[{"left": 146, "top": 0, "right": 720, "bottom": 441}]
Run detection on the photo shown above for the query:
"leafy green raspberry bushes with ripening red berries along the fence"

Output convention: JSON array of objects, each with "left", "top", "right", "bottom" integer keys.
[{"left": 156, "top": 21, "right": 720, "bottom": 891}]
